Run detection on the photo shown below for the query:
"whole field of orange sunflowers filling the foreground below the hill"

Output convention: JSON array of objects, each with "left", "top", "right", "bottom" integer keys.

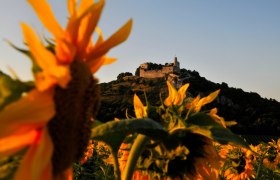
[{"left": 0, "top": 0, "right": 280, "bottom": 180}]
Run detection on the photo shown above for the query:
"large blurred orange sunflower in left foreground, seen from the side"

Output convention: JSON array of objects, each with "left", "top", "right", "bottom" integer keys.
[{"left": 0, "top": 0, "right": 132, "bottom": 180}]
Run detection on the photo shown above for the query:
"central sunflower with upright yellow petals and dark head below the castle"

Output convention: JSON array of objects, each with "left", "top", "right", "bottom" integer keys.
[{"left": 127, "top": 85, "right": 225, "bottom": 179}]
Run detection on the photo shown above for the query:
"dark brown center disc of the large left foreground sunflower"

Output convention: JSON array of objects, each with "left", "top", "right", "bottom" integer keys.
[{"left": 48, "top": 61, "right": 99, "bottom": 175}]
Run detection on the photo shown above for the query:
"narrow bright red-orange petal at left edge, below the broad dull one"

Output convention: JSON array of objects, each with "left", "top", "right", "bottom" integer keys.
[{"left": 0, "top": 130, "right": 38, "bottom": 159}]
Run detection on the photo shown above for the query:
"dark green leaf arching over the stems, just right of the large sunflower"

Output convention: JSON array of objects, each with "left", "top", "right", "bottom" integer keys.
[{"left": 91, "top": 118, "right": 167, "bottom": 152}]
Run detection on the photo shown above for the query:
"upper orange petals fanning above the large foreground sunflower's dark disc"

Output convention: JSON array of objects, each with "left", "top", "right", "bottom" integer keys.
[{"left": 24, "top": 0, "right": 132, "bottom": 90}]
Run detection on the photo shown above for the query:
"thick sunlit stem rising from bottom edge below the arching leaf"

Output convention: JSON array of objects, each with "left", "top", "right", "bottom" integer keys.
[{"left": 122, "top": 134, "right": 149, "bottom": 180}]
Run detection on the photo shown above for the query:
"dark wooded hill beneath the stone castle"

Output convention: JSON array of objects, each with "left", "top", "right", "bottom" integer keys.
[{"left": 97, "top": 64, "right": 280, "bottom": 135}]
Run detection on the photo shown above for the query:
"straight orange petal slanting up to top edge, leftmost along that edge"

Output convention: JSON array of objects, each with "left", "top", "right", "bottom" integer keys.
[{"left": 28, "top": 0, "right": 63, "bottom": 38}]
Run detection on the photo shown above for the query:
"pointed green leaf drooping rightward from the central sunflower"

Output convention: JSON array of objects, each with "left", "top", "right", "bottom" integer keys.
[{"left": 186, "top": 113, "right": 249, "bottom": 148}]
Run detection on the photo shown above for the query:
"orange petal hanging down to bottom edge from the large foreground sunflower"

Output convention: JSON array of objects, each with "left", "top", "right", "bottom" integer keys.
[{"left": 15, "top": 127, "right": 53, "bottom": 180}]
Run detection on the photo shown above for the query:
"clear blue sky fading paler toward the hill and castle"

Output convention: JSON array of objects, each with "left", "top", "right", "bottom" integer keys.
[{"left": 0, "top": 0, "right": 280, "bottom": 101}]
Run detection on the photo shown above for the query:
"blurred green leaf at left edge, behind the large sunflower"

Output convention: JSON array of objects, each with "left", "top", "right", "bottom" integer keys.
[{"left": 0, "top": 71, "right": 34, "bottom": 110}]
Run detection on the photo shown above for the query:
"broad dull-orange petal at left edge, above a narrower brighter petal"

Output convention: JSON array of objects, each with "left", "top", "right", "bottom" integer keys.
[{"left": 0, "top": 89, "right": 55, "bottom": 138}]
